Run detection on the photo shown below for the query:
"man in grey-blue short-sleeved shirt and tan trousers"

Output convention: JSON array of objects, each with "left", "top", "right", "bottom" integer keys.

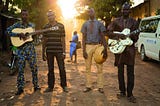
[{"left": 81, "top": 8, "right": 107, "bottom": 93}]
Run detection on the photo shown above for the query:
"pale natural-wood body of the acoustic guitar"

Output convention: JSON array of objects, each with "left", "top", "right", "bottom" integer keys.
[{"left": 11, "top": 27, "right": 34, "bottom": 47}]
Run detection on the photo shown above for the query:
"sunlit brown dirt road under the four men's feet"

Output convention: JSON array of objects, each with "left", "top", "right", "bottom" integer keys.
[{"left": 0, "top": 46, "right": 160, "bottom": 106}]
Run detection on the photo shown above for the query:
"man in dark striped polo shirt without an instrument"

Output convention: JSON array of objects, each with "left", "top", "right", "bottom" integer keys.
[{"left": 42, "top": 10, "right": 68, "bottom": 92}]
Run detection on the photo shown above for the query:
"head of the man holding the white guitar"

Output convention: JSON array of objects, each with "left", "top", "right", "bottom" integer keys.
[{"left": 121, "top": 2, "right": 131, "bottom": 18}]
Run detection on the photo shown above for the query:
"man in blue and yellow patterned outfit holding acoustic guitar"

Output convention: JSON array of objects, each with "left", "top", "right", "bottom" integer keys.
[{"left": 7, "top": 10, "right": 40, "bottom": 95}]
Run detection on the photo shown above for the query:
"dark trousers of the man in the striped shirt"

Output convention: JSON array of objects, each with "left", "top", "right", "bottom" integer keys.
[{"left": 47, "top": 53, "right": 67, "bottom": 89}]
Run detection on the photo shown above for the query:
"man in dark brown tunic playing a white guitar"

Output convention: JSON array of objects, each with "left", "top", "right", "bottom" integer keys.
[{"left": 107, "top": 2, "right": 138, "bottom": 103}]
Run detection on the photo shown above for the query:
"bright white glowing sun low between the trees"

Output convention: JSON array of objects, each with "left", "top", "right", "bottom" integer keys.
[{"left": 57, "top": 0, "right": 77, "bottom": 19}]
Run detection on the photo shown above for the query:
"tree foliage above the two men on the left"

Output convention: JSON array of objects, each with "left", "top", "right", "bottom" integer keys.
[{"left": 0, "top": 0, "right": 61, "bottom": 29}]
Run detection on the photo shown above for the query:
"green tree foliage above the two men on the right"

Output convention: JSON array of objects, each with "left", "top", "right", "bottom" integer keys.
[{"left": 74, "top": 0, "right": 132, "bottom": 24}]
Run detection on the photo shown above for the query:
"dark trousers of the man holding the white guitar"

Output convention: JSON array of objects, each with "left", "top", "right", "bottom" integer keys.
[{"left": 118, "top": 64, "right": 134, "bottom": 97}]
